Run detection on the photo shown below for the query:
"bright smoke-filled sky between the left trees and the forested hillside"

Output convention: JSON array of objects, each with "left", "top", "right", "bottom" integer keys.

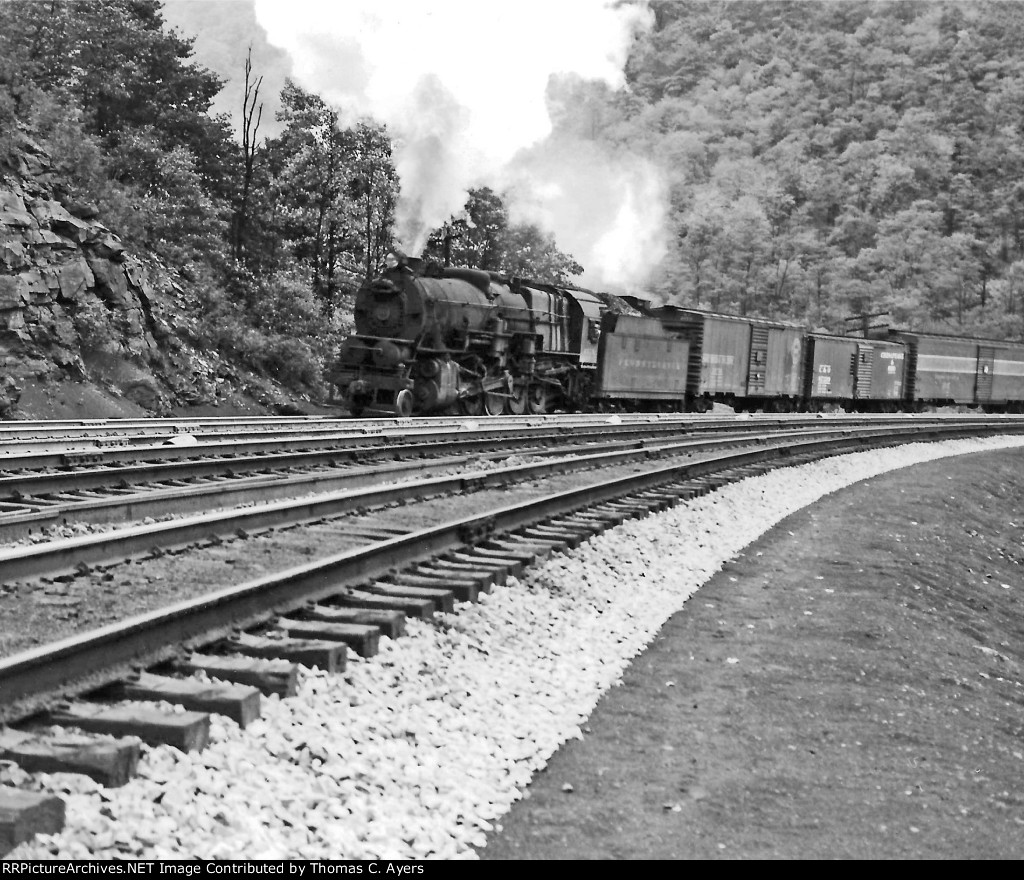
[{"left": 165, "top": 0, "right": 667, "bottom": 292}]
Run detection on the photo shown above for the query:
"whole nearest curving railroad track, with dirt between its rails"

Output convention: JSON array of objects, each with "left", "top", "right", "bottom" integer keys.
[{"left": 0, "top": 417, "right": 1024, "bottom": 856}]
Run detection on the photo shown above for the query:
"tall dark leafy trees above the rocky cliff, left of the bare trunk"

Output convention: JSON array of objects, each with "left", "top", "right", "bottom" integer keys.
[{"left": 0, "top": 0, "right": 234, "bottom": 260}]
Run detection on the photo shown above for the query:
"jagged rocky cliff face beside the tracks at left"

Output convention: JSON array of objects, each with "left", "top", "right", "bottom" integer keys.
[{"left": 0, "top": 135, "right": 311, "bottom": 417}]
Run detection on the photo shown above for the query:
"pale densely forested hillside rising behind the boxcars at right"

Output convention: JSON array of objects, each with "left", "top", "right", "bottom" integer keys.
[{"left": 614, "top": 2, "right": 1024, "bottom": 338}]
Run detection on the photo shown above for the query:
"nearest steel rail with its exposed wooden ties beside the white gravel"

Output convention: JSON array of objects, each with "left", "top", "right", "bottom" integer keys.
[{"left": 0, "top": 419, "right": 1024, "bottom": 856}]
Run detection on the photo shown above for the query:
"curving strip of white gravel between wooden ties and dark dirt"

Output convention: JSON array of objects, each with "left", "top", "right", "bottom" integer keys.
[{"left": 8, "top": 437, "right": 1024, "bottom": 858}]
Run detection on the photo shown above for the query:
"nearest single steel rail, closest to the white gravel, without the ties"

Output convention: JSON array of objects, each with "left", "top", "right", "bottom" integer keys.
[{"left": 0, "top": 417, "right": 1015, "bottom": 722}]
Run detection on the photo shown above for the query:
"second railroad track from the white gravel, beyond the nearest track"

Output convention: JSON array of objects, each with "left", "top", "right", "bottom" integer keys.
[{"left": 0, "top": 417, "right": 1007, "bottom": 543}]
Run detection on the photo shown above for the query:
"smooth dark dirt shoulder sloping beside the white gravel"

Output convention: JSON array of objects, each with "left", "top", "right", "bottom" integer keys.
[{"left": 480, "top": 450, "right": 1024, "bottom": 860}]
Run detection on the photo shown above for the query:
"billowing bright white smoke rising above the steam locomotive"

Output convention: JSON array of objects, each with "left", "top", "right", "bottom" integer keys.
[{"left": 256, "top": 0, "right": 655, "bottom": 283}]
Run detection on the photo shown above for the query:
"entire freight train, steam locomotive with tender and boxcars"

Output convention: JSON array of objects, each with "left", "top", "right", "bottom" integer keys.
[{"left": 328, "top": 258, "right": 1024, "bottom": 416}]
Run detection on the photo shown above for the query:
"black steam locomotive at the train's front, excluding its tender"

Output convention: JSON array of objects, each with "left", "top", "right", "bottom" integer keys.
[{"left": 328, "top": 258, "right": 607, "bottom": 416}]
